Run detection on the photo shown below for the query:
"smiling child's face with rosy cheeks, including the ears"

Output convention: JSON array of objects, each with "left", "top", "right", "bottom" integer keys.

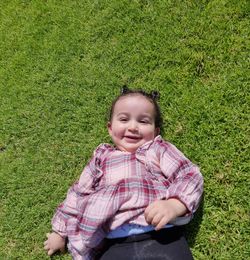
[{"left": 108, "top": 95, "right": 160, "bottom": 152}]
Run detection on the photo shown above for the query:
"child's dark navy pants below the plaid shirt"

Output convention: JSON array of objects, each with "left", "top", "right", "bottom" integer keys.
[{"left": 99, "top": 227, "right": 193, "bottom": 260}]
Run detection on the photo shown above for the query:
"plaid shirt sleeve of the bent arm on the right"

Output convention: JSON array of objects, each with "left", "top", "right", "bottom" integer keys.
[{"left": 157, "top": 141, "right": 203, "bottom": 215}]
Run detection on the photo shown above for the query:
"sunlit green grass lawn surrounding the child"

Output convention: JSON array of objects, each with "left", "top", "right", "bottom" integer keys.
[{"left": 0, "top": 0, "right": 250, "bottom": 260}]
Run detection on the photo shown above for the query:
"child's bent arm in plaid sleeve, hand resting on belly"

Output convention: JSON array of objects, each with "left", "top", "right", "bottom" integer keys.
[{"left": 145, "top": 138, "right": 203, "bottom": 229}]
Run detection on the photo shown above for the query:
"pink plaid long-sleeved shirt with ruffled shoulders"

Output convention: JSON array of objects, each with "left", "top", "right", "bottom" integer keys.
[{"left": 52, "top": 136, "right": 203, "bottom": 259}]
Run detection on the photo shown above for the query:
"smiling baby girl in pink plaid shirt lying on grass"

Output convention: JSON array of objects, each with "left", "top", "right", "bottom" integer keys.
[{"left": 44, "top": 87, "right": 203, "bottom": 260}]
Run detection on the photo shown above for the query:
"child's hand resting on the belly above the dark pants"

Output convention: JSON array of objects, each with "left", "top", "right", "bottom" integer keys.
[{"left": 144, "top": 199, "right": 187, "bottom": 230}]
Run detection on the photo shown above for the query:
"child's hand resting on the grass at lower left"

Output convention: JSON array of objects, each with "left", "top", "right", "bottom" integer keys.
[{"left": 44, "top": 232, "right": 66, "bottom": 256}]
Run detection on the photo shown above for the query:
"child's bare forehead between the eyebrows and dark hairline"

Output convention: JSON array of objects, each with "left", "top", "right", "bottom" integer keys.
[{"left": 114, "top": 94, "right": 155, "bottom": 114}]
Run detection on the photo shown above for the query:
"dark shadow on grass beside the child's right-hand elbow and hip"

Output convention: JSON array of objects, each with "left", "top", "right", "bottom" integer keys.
[{"left": 185, "top": 195, "right": 204, "bottom": 247}]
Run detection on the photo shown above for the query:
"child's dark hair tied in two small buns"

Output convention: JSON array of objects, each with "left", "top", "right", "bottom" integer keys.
[{"left": 109, "top": 86, "right": 163, "bottom": 130}]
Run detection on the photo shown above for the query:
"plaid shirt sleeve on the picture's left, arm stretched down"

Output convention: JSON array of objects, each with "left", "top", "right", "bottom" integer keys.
[{"left": 52, "top": 145, "right": 104, "bottom": 237}]
